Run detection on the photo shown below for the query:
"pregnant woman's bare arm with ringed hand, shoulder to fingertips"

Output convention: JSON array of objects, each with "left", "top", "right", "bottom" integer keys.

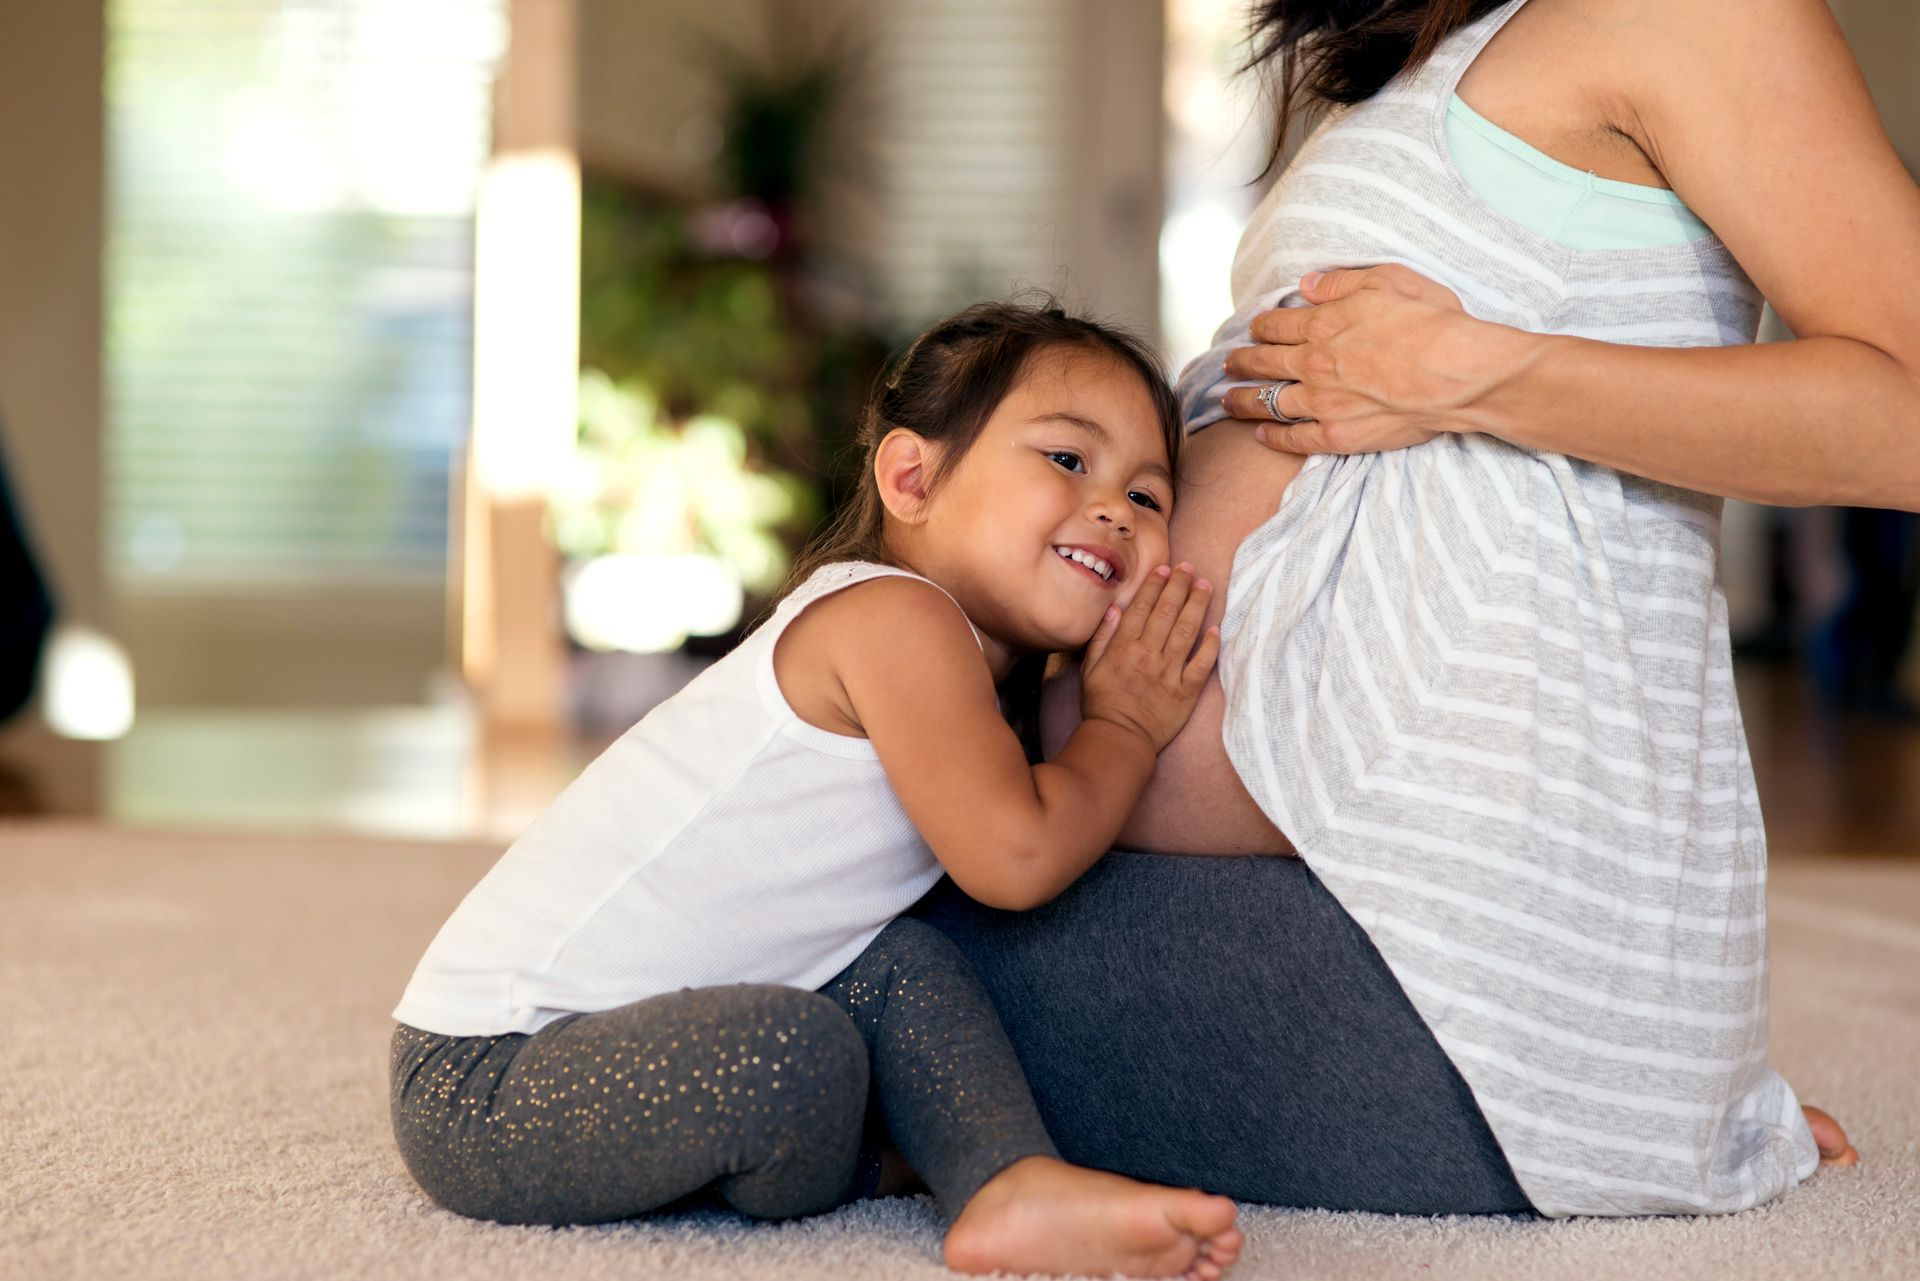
[{"left": 1229, "top": 0, "right": 1920, "bottom": 509}]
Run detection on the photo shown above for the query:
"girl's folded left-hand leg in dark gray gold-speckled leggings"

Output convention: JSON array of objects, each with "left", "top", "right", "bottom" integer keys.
[{"left": 392, "top": 985, "right": 876, "bottom": 1223}]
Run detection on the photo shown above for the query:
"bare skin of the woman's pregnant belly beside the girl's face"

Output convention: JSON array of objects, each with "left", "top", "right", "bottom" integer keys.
[{"left": 1041, "top": 423, "right": 1306, "bottom": 855}]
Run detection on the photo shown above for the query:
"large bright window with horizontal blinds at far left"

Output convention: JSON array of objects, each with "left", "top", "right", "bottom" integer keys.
[{"left": 106, "top": 0, "right": 505, "bottom": 592}]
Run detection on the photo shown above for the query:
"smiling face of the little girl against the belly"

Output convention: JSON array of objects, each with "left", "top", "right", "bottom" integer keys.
[{"left": 916, "top": 348, "right": 1173, "bottom": 655}]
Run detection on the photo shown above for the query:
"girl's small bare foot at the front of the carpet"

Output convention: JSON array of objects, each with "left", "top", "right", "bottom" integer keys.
[{"left": 947, "top": 1156, "right": 1240, "bottom": 1281}]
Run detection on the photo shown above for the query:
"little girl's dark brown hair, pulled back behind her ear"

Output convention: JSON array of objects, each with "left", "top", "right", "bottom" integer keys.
[{"left": 755, "top": 298, "right": 1181, "bottom": 759}]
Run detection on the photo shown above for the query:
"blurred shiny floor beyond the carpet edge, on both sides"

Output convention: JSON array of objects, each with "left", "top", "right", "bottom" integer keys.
[{"left": 0, "top": 661, "right": 1920, "bottom": 858}]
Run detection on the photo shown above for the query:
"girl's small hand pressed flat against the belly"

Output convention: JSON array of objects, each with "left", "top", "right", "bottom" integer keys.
[{"left": 1081, "top": 563, "right": 1219, "bottom": 753}]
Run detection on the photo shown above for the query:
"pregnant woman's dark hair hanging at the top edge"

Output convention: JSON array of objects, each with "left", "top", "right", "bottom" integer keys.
[{"left": 1240, "top": 0, "right": 1505, "bottom": 177}]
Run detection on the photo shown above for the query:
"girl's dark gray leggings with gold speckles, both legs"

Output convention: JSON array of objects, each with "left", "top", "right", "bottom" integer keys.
[{"left": 392, "top": 920, "right": 1054, "bottom": 1223}]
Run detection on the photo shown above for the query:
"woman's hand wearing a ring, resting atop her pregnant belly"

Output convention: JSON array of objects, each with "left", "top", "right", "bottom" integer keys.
[{"left": 1227, "top": 265, "right": 1536, "bottom": 453}]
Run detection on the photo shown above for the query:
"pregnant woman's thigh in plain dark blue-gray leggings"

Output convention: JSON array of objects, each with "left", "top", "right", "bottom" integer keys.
[{"left": 916, "top": 853, "right": 1530, "bottom": 1214}]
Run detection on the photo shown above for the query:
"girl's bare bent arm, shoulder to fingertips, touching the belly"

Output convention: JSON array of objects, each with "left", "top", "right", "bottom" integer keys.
[{"left": 831, "top": 570, "right": 1219, "bottom": 910}]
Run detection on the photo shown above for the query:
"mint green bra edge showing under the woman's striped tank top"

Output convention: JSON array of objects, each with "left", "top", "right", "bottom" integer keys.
[{"left": 1446, "top": 94, "right": 1713, "bottom": 250}]
